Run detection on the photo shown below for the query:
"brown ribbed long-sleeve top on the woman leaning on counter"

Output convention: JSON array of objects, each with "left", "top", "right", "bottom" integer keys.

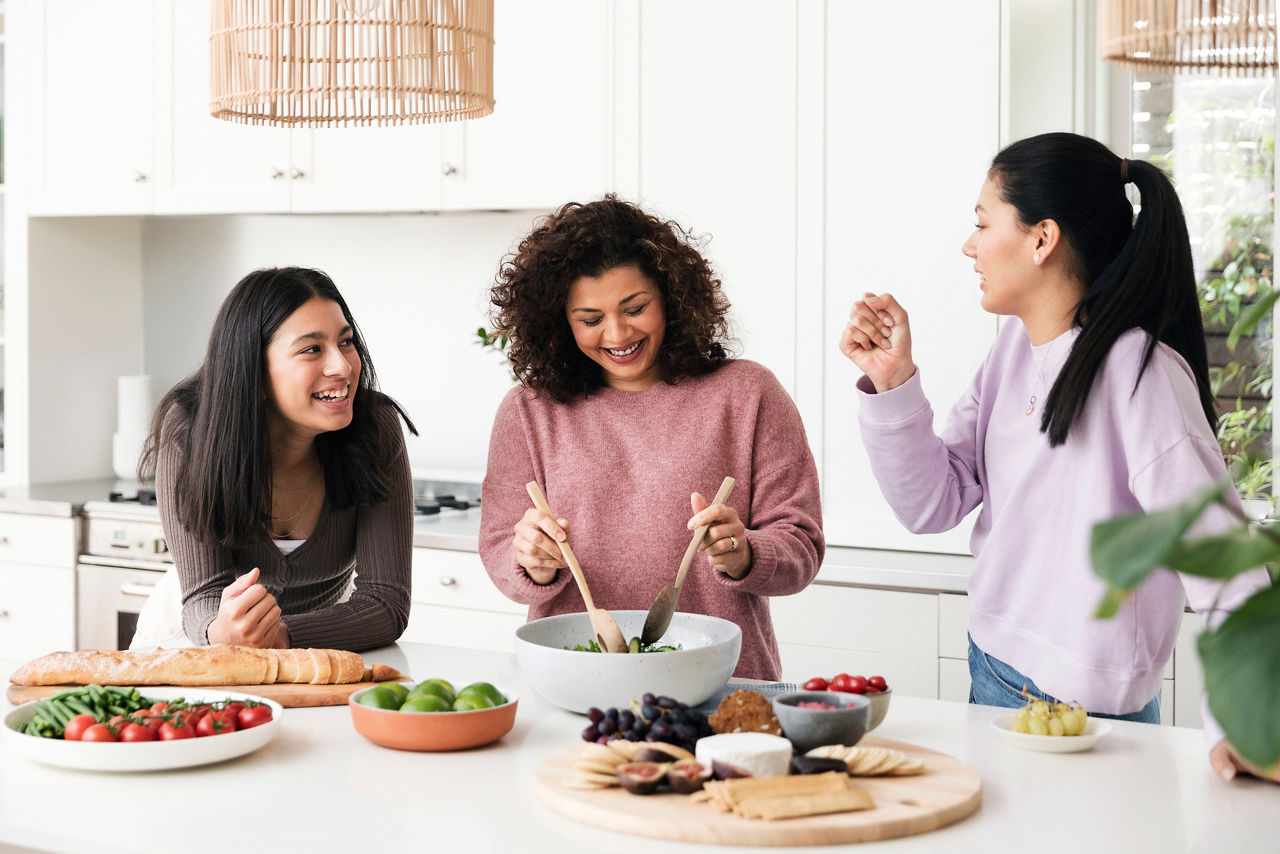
[{"left": 156, "top": 406, "right": 413, "bottom": 652}]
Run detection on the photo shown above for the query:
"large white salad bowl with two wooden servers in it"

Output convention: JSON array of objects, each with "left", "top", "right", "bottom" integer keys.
[{"left": 516, "top": 611, "right": 742, "bottom": 714}]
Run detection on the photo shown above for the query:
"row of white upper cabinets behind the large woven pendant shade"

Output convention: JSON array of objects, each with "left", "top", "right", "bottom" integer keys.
[{"left": 29, "top": 0, "right": 613, "bottom": 215}]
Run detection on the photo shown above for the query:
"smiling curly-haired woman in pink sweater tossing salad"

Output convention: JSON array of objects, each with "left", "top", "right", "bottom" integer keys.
[{"left": 480, "top": 196, "right": 826, "bottom": 679}]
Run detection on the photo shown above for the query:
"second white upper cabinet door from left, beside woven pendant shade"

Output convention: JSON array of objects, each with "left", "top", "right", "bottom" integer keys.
[{"left": 152, "top": 0, "right": 291, "bottom": 214}]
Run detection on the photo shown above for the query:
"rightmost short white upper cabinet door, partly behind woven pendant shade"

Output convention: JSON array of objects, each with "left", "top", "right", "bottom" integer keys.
[{"left": 439, "top": 0, "right": 613, "bottom": 210}]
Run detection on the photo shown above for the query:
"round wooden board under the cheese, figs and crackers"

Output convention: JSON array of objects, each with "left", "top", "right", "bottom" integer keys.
[{"left": 534, "top": 737, "right": 982, "bottom": 845}]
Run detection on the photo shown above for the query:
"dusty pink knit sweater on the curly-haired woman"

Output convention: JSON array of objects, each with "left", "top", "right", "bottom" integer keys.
[{"left": 480, "top": 360, "right": 826, "bottom": 679}]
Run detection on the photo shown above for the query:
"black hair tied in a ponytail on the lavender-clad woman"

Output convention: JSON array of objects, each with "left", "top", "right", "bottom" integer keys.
[{"left": 989, "top": 133, "right": 1217, "bottom": 446}]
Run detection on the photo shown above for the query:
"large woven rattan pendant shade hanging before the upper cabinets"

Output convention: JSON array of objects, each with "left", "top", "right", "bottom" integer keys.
[{"left": 209, "top": 0, "right": 493, "bottom": 128}]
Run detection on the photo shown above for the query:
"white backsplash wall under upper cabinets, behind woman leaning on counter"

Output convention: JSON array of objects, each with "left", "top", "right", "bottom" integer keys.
[{"left": 142, "top": 211, "right": 540, "bottom": 471}]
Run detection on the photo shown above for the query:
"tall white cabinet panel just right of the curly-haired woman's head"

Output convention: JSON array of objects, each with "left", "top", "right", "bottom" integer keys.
[{"left": 632, "top": 0, "right": 797, "bottom": 386}]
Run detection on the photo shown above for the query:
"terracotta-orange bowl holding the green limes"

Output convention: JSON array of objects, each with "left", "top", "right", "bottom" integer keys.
[{"left": 348, "top": 688, "right": 517, "bottom": 750}]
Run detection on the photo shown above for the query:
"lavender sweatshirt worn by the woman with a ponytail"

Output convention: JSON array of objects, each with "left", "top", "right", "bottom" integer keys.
[{"left": 858, "top": 318, "right": 1267, "bottom": 729}]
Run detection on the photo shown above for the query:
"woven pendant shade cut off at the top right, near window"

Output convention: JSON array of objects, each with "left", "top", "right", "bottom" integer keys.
[{"left": 1098, "top": 0, "right": 1276, "bottom": 76}]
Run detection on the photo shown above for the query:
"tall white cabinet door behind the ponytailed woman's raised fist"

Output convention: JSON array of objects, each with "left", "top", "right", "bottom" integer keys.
[{"left": 823, "top": 0, "right": 1001, "bottom": 553}]
